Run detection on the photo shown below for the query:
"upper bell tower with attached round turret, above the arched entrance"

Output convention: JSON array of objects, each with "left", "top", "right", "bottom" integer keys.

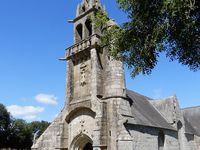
[{"left": 65, "top": 0, "right": 125, "bottom": 109}]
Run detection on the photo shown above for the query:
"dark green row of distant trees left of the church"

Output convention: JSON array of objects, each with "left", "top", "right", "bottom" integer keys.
[{"left": 0, "top": 104, "right": 50, "bottom": 149}]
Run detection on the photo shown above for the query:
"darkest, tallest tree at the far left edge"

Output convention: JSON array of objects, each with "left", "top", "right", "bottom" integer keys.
[{"left": 0, "top": 104, "right": 11, "bottom": 148}]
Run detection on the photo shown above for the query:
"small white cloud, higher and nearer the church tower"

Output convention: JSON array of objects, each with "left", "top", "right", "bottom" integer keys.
[{"left": 35, "top": 93, "right": 58, "bottom": 105}]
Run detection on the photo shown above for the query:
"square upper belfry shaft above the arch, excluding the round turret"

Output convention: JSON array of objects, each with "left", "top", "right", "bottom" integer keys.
[{"left": 65, "top": 0, "right": 101, "bottom": 105}]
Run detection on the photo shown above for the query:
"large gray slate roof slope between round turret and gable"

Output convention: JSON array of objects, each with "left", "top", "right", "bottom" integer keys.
[{"left": 127, "top": 90, "right": 176, "bottom": 130}]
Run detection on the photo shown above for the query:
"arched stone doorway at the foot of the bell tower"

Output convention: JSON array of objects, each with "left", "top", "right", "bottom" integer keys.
[{"left": 70, "top": 134, "right": 93, "bottom": 150}]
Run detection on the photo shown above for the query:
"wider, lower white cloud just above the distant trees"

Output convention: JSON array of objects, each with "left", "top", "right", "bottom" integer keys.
[{"left": 7, "top": 105, "right": 44, "bottom": 120}]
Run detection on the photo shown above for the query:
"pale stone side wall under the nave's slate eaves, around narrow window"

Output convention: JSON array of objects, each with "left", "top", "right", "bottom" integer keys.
[{"left": 125, "top": 125, "right": 179, "bottom": 150}]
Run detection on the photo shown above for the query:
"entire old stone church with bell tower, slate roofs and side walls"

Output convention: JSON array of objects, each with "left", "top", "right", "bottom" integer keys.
[{"left": 32, "top": 0, "right": 200, "bottom": 150}]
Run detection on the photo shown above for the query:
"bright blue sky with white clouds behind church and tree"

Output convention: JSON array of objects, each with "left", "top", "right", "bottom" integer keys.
[{"left": 0, "top": 0, "right": 200, "bottom": 121}]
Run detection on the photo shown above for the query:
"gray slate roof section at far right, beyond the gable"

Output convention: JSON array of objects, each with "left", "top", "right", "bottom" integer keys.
[{"left": 182, "top": 106, "right": 200, "bottom": 136}]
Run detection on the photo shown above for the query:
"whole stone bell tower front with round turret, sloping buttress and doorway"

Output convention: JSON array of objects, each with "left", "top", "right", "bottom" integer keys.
[{"left": 32, "top": 0, "right": 126, "bottom": 150}]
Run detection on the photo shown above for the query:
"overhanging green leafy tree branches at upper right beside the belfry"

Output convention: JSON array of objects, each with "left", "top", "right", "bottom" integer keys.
[{"left": 95, "top": 0, "right": 200, "bottom": 76}]
